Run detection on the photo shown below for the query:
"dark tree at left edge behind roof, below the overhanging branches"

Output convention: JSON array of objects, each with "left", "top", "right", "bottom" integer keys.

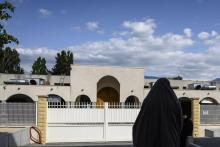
[{"left": 0, "top": 47, "right": 24, "bottom": 74}]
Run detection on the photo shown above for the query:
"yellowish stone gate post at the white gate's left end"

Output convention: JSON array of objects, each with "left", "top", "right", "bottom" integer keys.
[{"left": 37, "top": 96, "right": 47, "bottom": 144}]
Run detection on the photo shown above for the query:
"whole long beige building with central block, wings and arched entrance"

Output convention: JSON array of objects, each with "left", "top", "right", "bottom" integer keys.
[{"left": 0, "top": 65, "right": 220, "bottom": 103}]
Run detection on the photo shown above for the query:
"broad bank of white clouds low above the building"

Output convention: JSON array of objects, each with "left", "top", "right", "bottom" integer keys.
[{"left": 18, "top": 19, "right": 220, "bottom": 79}]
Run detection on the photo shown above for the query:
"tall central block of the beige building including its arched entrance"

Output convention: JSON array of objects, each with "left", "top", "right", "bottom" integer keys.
[{"left": 70, "top": 66, "right": 144, "bottom": 102}]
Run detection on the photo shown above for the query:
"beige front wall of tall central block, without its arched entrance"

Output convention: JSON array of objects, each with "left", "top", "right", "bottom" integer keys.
[{"left": 71, "top": 65, "right": 144, "bottom": 102}]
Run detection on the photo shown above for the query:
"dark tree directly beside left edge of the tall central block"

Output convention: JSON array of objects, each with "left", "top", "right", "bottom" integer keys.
[{"left": 52, "top": 50, "right": 74, "bottom": 75}]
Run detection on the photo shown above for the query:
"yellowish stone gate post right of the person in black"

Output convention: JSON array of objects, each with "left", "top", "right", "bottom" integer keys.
[{"left": 192, "top": 98, "right": 200, "bottom": 137}]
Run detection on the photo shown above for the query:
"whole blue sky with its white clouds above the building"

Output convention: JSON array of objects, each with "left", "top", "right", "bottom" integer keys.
[{"left": 5, "top": 0, "right": 220, "bottom": 79}]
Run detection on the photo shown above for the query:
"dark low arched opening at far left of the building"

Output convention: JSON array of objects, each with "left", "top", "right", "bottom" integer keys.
[{"left": 6, "top": 94, "right": 34, "bottom": 103}]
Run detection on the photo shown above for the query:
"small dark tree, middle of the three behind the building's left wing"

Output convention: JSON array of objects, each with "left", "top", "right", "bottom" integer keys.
[{"left": 32, "top": 57, "right": 48, "bottom": 75}]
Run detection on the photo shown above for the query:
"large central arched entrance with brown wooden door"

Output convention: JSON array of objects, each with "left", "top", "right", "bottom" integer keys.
[{"left": 96, "top": 76, "right": 120, "bottom": 105}]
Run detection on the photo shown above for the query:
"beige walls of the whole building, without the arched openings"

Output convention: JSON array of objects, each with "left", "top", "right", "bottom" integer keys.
[{"left": 0, "top": 65, "right": 220, "bottom": 103}]
